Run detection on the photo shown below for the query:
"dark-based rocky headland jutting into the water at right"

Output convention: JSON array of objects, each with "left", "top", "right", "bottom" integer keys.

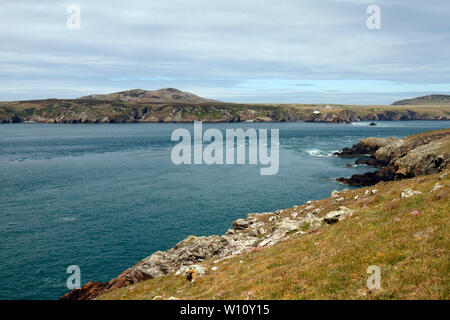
[{"left": 336, "top": 129, "right": 450, "bottom": 186}]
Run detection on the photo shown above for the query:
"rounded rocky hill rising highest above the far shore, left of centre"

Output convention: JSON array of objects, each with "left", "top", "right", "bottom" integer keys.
[{"left": 78, "top": 88, "right": 217, "bottom": 103}]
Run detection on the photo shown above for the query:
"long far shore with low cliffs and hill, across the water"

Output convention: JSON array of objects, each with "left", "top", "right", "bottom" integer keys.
[{"left": 0, "top": 93, "right": 450, "bottom": 123}]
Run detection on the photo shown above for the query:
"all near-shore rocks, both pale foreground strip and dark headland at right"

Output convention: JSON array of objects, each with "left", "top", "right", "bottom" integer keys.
[{"left": 60, "top": 129, "right": 450, "bottom": 300}]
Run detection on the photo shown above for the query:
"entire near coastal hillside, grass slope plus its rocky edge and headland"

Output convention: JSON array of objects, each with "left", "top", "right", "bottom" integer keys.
[{"left": 62, "top": 129, "right": 450, "bottom": 299}]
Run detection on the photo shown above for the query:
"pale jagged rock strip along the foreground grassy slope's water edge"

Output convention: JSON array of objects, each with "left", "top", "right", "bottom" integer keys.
[{"left": 60, "top": 200, "right": 353, "bottom": 300}]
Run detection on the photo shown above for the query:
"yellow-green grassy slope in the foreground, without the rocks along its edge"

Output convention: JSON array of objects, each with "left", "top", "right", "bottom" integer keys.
[{"left": 99, "top": 170, "right": 450, "bottom": 299}]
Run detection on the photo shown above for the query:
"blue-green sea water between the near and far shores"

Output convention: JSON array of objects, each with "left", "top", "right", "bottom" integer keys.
[{"left": 0, "top": 121, "right": 450, "bottom": 299}]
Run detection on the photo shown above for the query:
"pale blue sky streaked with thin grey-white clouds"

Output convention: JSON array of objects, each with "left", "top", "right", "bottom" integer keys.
[{"left": 0, "top": 0, "right": 450, "bottom": 105}]
